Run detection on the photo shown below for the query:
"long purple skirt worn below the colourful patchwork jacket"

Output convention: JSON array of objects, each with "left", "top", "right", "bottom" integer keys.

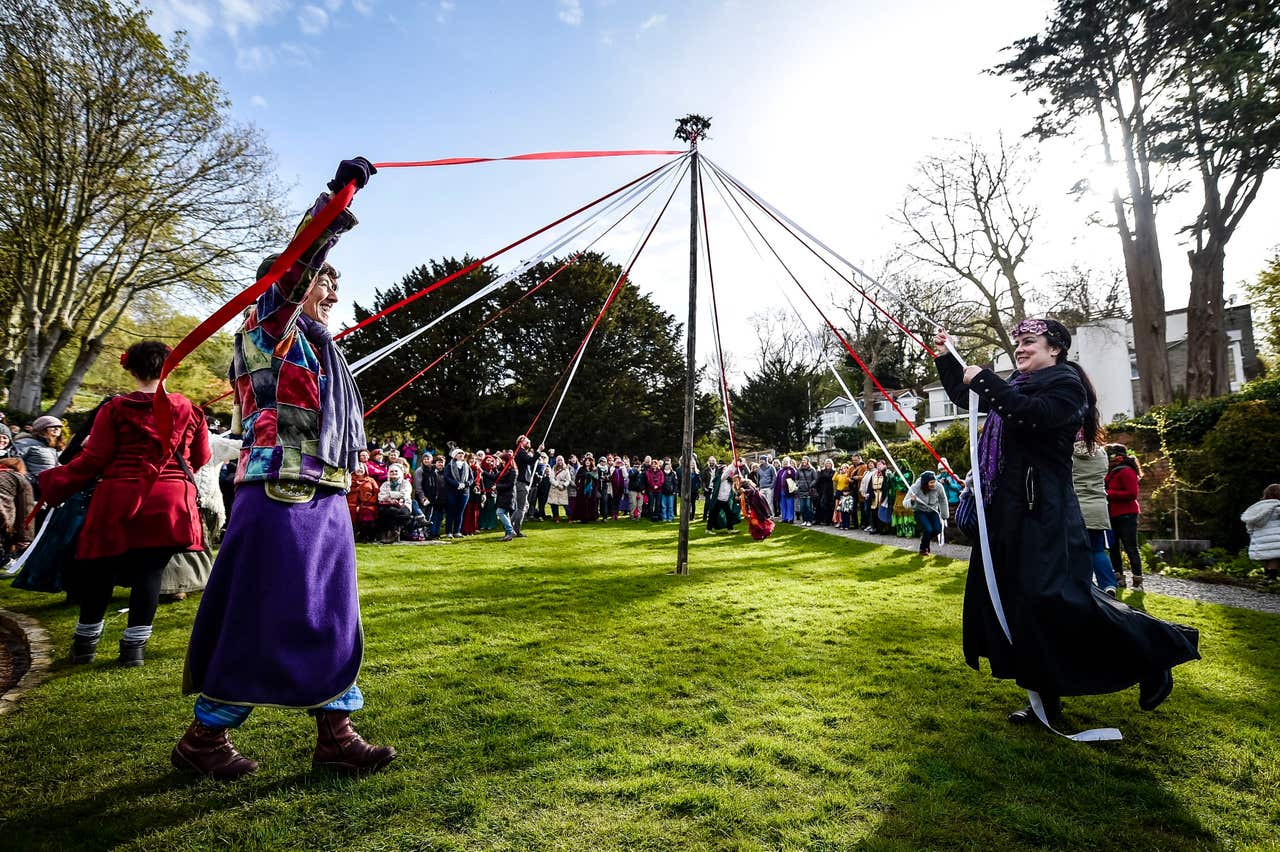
[{"left": 182, "top": 482, "right": 365, "bottom": 707}]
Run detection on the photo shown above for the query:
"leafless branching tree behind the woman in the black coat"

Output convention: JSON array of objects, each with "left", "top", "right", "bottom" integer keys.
[{"left": 897, "top": 137, "right": 1039, "bottom": 357}]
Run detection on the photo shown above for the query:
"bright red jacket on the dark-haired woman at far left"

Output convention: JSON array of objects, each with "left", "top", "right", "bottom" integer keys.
[{"left": 40, "top": 391, "right": 209, "bottom": 559}]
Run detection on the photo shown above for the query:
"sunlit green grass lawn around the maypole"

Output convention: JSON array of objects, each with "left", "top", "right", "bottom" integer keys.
[{"left": 0, "top": 522, "right": 1280, "bottom": 852}]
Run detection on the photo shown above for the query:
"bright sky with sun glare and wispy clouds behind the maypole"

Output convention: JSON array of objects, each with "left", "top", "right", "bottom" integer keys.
[{"left": 146, "top": 0, "right": 1280, "bottom": 378}]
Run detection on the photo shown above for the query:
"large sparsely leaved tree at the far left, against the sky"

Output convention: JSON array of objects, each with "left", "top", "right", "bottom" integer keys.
[{"left": 0, "top": 0, "right": 283, "bottom": 413}]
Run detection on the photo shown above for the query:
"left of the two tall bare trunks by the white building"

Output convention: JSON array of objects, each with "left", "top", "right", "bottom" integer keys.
[{"left": 1116, "top": 198, "right": 1174, "bottom": 413}]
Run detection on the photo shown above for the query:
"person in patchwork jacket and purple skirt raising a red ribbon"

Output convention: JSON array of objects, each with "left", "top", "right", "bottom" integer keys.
[{"left": 170, "top": 157, "right": 396, "bottom": 780}]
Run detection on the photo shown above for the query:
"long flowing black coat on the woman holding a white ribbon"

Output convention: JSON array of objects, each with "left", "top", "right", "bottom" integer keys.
[{"left": 937, "top": 354, "right": 1199, "bottom": 696}]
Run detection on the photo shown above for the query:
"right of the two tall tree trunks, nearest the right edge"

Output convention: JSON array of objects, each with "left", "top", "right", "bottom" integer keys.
[{"left": 1187, "top": 238, "right": 1230, "bottom": 399}]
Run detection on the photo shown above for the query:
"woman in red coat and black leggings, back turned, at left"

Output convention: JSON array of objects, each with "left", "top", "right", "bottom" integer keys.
[{"left": 40, "top": 340, "right": 209, "bottom": 665}]
